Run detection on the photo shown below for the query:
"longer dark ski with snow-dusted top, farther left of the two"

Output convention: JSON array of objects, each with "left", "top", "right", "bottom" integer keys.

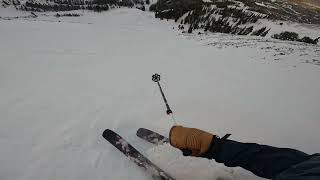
[{"left": 102, "top": 129, "right": 174, "bottom": 180}]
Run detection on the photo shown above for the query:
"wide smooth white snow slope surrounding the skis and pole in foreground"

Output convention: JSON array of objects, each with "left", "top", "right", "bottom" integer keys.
[{"left": 0, "top": 9, "right": 320, "bottom": 180}]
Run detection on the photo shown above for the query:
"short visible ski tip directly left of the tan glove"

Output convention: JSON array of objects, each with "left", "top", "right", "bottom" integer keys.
[{"left": 136, "top": 128, "right": 169, "bottom": 145}]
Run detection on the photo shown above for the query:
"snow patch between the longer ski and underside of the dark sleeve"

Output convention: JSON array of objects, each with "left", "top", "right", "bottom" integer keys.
[{"left": 147, "top": 144, "right": 262, "bottom": 180}]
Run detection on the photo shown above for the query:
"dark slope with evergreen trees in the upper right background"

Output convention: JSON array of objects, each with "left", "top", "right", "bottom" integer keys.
[{"left": 150, "top": 0, "right": 320, "bottom": 44}]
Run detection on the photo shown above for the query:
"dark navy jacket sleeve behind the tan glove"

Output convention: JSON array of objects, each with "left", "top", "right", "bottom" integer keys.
[{"left": 204, "top": 137, "right": 310, "bottom": 179}]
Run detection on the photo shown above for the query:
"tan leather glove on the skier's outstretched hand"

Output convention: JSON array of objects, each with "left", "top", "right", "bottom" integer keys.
[{"left": 169, "top": 126, "right": 214, "bottom": 156}]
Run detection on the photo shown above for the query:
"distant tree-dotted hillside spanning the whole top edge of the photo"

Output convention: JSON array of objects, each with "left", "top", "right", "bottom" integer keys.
[{"left": 0, "top": 0, "right": 320, "bottom": 44}]
